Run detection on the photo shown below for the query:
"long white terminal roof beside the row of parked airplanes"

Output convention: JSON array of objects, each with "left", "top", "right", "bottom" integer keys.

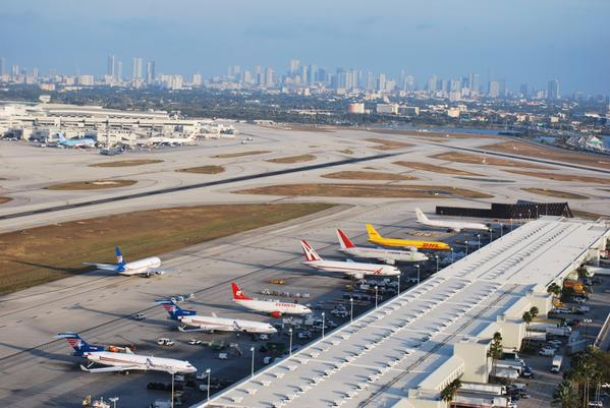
[{"left": 196, "top": 217, "right": 609, "bottom": 408}]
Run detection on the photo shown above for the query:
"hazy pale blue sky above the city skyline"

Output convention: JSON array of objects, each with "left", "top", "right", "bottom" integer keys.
[{"left": 0, "top": 0, "right": 610, "bottom": 94}]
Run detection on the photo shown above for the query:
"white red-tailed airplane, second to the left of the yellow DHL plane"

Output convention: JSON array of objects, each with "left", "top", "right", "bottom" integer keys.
[{"left": 301, "top": 241, "right": 400, "bottom": 279}]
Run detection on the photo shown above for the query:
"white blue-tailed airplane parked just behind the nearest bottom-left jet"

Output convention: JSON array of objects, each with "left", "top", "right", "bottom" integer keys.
[{"left": 158, "top": 300, "right": 277, "bottom": 334}]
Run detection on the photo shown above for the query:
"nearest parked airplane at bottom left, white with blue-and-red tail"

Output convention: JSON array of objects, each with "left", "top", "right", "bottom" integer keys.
[{"left": 56, "top": 333, "right": 197, "bottom": 374}]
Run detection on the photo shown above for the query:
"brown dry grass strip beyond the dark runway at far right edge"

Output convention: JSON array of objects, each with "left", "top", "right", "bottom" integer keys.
[{"left": 480, "top": 141, "right": 610, "bottom": 169}]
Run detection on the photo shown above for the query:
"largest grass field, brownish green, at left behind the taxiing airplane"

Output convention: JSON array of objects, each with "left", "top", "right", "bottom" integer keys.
[{"left": 0, "top": 204, "right": 332, "bottom": 294}]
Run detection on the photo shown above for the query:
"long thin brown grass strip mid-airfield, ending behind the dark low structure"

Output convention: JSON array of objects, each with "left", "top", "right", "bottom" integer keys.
[{"left": 237, "top": 184, "right": 493, "bottom": 198}]
